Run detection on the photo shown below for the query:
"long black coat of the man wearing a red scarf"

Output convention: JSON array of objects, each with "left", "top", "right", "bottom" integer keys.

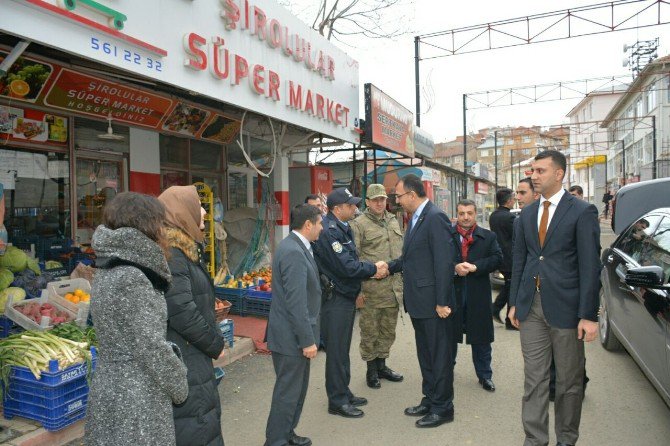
[{"left": 453, "top": 226, "right": 502, "bottom": 344}]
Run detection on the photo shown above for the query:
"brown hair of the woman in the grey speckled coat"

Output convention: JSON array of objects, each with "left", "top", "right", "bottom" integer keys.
[{"left": 102, "top": 192, "right": 167, "bottom": 248}]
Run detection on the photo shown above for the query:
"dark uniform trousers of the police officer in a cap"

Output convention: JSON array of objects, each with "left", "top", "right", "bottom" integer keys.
[{"left": 321, "top": 293, "right": 356, "bottom": 407}]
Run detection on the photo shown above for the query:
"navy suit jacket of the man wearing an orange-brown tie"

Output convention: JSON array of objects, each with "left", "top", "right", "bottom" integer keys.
[{"left": 509, "top": 192, "right": 602, "bottom": 328}]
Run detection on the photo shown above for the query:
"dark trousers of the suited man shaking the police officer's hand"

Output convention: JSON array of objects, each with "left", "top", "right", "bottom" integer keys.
[{"left": 412, "top": 317, "right": 455, "bottom": 416}]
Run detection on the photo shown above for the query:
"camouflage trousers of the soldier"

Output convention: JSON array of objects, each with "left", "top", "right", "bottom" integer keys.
[{"left": 358, "top": 307, "right": 398, "bottom": 361}]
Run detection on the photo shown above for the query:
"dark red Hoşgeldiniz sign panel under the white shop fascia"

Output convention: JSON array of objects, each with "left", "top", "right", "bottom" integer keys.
[{"left": 44, "top": 68, "right": 173, "bottom": 127}]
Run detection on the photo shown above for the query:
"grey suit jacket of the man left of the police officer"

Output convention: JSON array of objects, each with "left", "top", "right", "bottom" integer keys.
[{"left": 267, "top": 233, "right": 321, "bottom": 356}]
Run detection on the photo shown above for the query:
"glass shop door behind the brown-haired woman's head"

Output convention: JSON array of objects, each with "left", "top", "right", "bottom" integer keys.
[{"left": 75, "top": 151, "right": 127, "bottom": 245}]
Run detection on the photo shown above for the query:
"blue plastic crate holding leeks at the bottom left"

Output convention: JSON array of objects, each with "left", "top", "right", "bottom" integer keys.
[{"left": 3, "top": 347, "right": 96, "bottom": 431}]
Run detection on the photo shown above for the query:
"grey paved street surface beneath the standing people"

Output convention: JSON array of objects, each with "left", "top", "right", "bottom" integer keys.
[{"left": 219, "top": 229, "right": 670, "bottom": 446}]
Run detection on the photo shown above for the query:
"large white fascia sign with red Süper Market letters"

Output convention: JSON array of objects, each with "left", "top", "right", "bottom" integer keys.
[{"left": 0, "top": 0, "right": 359, "bottom": 142}]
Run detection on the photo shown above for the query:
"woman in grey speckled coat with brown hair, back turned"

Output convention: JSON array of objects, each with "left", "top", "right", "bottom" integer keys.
[{"left": 84, "top": 192, "right": 188, "bottom": 446}]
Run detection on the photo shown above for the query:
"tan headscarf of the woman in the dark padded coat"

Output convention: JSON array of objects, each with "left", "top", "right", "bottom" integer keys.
[{"left": 158, "top": 186, "right": 205, "bottom": 243}]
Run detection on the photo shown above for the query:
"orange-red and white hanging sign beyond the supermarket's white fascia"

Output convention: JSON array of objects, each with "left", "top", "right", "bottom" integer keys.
[{"left": 365, "top": 84, "right": 414, "bottom": 156}]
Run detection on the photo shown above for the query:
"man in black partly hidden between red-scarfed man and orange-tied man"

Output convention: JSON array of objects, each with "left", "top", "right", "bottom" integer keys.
[{"left": 489, "top": 187, "right": 516, "bottom": 330}]
